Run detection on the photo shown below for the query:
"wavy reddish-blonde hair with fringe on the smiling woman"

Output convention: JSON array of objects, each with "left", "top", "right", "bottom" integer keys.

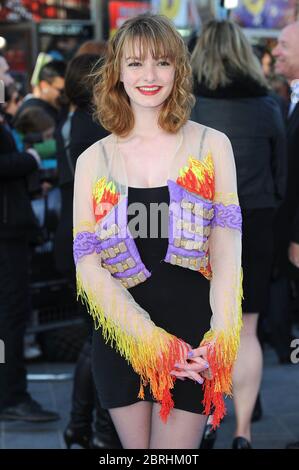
[{"left": 94, "top": 13, "right": 195, "bottom": 137}]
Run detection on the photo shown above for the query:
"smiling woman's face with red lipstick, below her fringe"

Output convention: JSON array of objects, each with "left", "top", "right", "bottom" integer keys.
[{"left": 120, "top": 41, "right": 175, "bottom": 110}]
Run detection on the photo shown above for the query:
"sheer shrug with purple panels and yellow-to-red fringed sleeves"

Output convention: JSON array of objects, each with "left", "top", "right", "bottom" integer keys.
[{"left": 74, "top": 121, "right": 242, "bottom": 427}]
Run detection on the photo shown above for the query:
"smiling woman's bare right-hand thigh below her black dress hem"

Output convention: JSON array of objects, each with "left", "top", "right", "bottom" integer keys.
[{"left": 149, "top": 403, "right": 207, "bottom": 449}]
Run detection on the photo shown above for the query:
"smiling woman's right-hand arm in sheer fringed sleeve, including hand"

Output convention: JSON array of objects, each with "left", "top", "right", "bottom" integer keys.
[{"left": 173, "top": 130, "right": 242, "bottom": 427}]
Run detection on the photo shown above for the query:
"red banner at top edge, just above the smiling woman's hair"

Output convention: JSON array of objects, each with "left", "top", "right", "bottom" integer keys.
[{"left": 109, "top": 1, "right": 151, "bottom": 37}]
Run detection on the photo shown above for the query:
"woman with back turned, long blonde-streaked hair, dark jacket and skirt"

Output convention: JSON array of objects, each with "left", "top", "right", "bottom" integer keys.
[{"left": 191, "top": 20, "right": 286, "bottom": 449}]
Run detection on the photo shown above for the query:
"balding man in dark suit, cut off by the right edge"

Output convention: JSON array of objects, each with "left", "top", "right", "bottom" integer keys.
[{"left": 272, "top": 21, "right": 299, "bottom": 449}]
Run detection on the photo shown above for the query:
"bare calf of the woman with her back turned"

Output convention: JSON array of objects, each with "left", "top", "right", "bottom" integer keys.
[{"left": 233, "top": 313, "right": 263, "bottom": 441}]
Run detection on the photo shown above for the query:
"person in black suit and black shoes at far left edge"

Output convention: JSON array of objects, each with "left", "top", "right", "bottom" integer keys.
[{"left": 0, "top": 96, "right": 59, "bottom": 423}]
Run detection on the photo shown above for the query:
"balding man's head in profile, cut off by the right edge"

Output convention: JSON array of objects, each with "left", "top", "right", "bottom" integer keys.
[{"left": 272, "top": 21, "right": 299, "bottom": 83}]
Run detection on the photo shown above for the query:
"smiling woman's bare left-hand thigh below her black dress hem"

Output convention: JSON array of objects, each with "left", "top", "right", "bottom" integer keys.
[{"left": 109, "top": 401, "right": 153, "bottom": 449}]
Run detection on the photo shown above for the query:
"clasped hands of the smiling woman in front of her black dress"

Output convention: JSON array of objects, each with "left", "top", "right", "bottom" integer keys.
[{"left": 171, "top": 346, "right": 212, "bottom": 384}]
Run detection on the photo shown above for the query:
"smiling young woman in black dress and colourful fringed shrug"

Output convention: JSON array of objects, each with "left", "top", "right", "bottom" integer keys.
[{"left": 74, "top": 14, "right": 242, "bottom": 449}]
